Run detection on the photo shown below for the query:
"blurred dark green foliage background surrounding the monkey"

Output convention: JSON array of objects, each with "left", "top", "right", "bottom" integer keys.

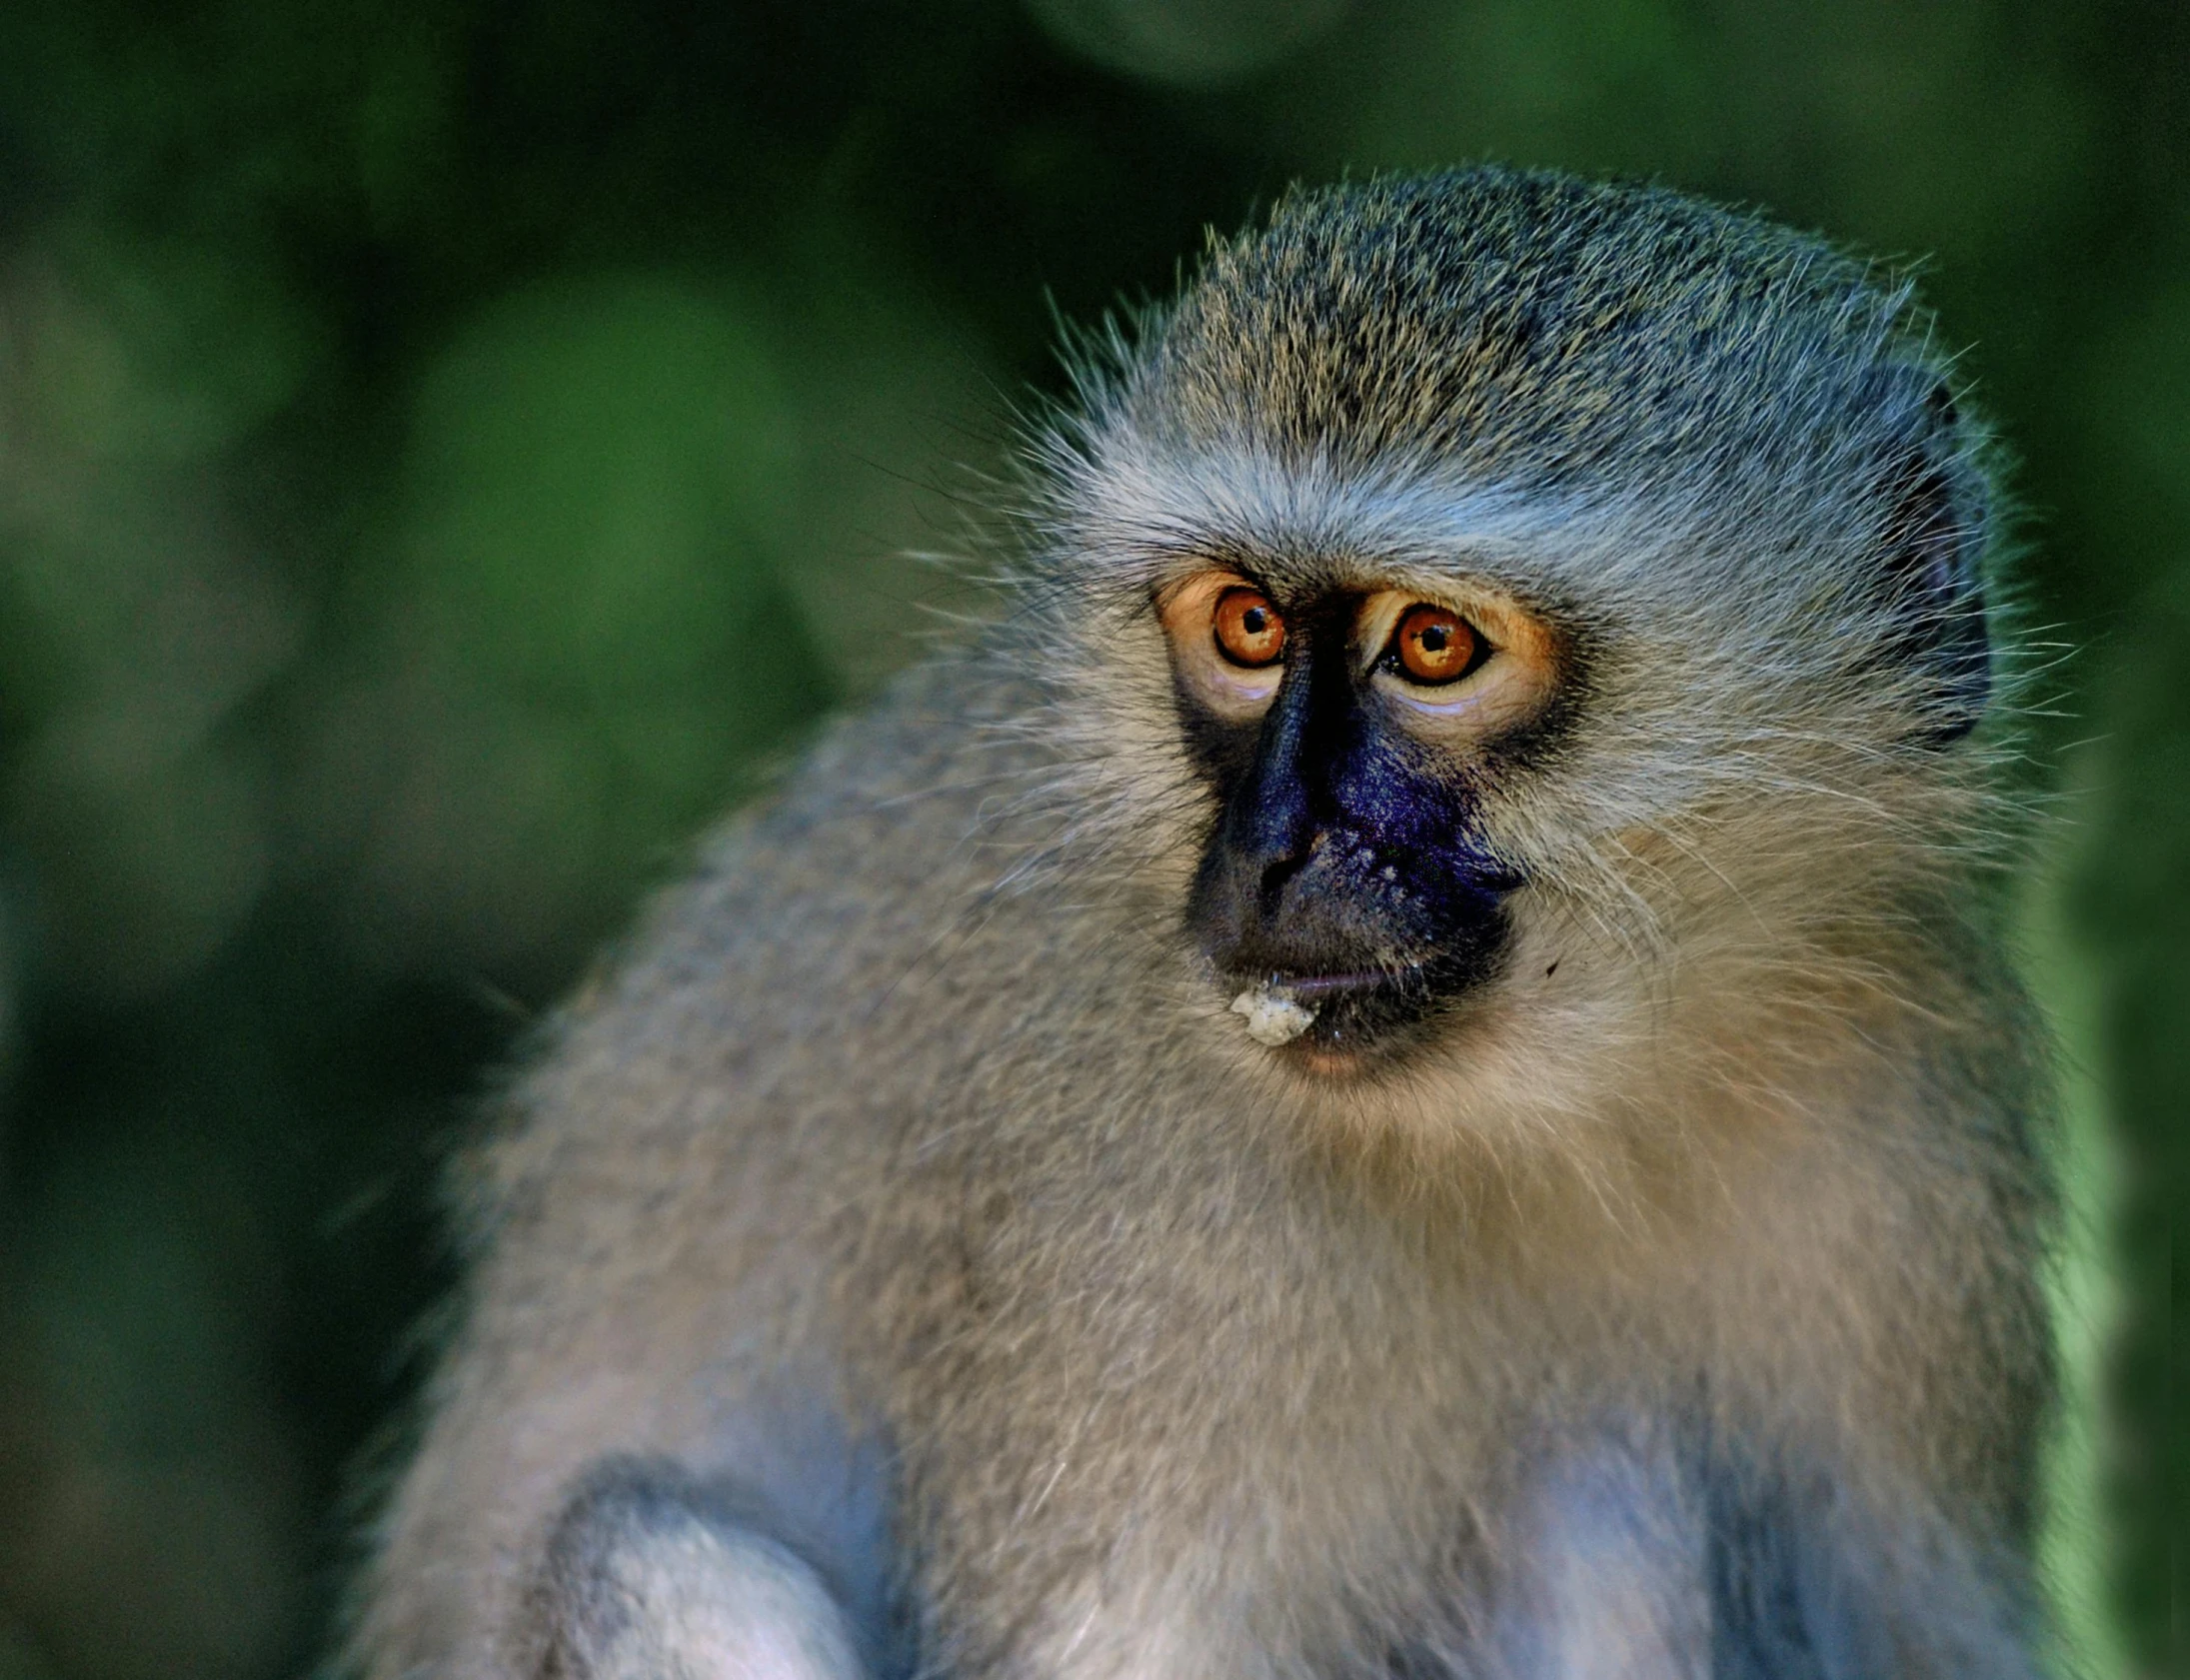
[{"left": 0, "top": 0, "right": 2190, "bottom": 1680}]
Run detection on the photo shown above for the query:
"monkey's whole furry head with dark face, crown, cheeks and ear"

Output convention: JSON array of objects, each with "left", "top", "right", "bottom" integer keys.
[{"left": 1028, "top": 171, "right": 1993, "bottom": 1077}]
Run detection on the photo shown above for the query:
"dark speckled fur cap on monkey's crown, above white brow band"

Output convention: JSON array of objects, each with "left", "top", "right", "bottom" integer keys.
[{"left": 1116, "top": 169, "right": 1934, "bottom": 482}]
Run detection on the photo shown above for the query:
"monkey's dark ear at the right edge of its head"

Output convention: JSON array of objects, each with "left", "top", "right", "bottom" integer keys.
[{"left": 1881, "top": 368, "right": 1993, "bottom": 745}]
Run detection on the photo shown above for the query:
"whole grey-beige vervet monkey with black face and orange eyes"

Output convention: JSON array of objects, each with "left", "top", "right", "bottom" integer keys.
[{"left": 357, "top": 169, "right": 2050, "bottom": 1680}]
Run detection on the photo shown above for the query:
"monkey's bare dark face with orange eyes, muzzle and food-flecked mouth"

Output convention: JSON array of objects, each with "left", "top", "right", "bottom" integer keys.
[{"left": 1158, "top": 570, "right": 1559, "bottom": 1064}]
